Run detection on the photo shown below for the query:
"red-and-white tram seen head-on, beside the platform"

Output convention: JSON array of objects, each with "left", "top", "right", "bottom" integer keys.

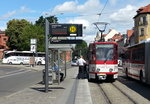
[{"left": 88, "top": 42, "right": 118, "bottom": 81}]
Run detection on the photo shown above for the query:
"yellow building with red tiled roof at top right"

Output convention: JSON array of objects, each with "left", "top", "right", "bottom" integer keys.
[{"left": 134, "top": 4, "right": 150, "bottom": 43}]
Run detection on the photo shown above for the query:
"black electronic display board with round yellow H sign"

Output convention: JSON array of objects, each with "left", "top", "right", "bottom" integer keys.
[{"left": 50, "top": 24, "right": 82, "bottom": 37}]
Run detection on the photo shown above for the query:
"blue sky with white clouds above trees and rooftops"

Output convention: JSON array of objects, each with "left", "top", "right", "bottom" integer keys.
[{"left": 0, "top": 0, "right": 150, "bottom": 43}]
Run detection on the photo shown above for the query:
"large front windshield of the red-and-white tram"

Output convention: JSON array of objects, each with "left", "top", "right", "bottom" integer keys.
[{"left": 96, "top": 44, "right": 114, "bottom": 61}]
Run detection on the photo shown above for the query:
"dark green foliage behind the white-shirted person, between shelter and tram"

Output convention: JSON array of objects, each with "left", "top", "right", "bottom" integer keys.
[{"left": 73, "top": 40, "right": 88, "bottom": 59}]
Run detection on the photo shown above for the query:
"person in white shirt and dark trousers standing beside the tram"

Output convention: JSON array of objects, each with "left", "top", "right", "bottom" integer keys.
[{"left": 77, "top": 56, "right": 86, "bottom": 78}]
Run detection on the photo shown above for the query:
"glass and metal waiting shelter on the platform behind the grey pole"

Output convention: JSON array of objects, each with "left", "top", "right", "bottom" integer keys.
[{"left": 49, "top": 44, "right": 72, "bottom": 84}]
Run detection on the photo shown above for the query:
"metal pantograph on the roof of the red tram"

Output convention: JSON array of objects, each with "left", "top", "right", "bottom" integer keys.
[{"left": 93, "top": 22, "right": 109, "bottom": 42}]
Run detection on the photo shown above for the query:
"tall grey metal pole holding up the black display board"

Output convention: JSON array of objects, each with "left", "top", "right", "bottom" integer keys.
[{"left": 45, "top": 19, "right": 49, "bottom": 93}]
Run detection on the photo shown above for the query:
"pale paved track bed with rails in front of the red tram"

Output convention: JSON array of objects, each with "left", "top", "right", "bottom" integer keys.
[{"left": 89, "top": 80, "right": 150, "bottom": 104}]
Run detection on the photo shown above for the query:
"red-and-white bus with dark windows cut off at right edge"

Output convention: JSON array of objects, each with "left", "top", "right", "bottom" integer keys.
[{"left": 123, "top": 40, "right": 150, "bottom": 84}]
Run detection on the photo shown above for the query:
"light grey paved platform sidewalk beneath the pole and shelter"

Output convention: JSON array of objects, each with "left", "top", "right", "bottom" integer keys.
[{"left": 0, "top": 66, "right": 92, "bottom": 104}]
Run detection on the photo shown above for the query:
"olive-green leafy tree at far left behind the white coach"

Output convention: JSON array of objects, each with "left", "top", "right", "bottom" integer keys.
[{"left": 6, "top": 19, "right": 30, "bottom": 50}]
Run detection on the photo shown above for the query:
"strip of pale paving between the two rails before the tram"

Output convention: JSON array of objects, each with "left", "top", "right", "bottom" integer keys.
[{"left": 97, "top": 83, "right": 137, "bottom": 104}]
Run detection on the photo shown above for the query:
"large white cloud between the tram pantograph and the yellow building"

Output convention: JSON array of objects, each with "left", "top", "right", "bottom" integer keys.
[{"left": 108, "top": 5, "right": 138, "bottom": 33}]
